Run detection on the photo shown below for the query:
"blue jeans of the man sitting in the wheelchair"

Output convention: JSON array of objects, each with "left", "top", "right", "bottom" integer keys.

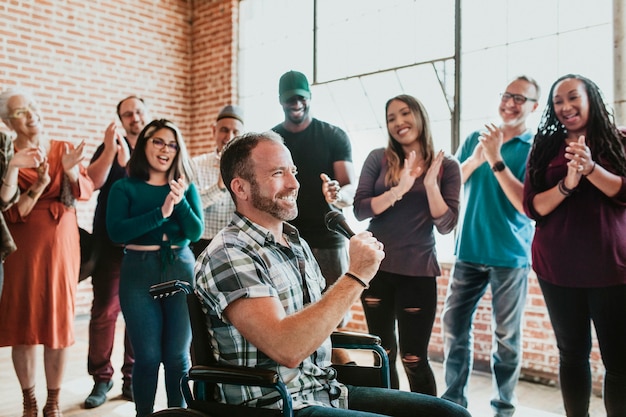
[{"left": 294, "top": 385, "right": 471, "bottom": 417}]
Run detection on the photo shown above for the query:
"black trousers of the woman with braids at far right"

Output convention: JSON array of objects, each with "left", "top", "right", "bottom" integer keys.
[{"left": 539, "top": 279, "right": 626, "bottom": 417}]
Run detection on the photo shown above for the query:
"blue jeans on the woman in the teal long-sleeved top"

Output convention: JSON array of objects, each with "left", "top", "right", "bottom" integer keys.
[{"left": 119, "top": 247, "right": 195, "bottom": 417}]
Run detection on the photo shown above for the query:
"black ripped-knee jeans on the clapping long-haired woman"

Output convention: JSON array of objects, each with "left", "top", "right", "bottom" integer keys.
[{"left": 361, "top": 271, "right": 437, "bottom": 395}]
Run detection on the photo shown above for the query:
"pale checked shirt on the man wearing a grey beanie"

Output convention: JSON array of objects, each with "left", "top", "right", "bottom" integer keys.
[{"left": 193, "top": 152, "right": 235, "bottom": 240}]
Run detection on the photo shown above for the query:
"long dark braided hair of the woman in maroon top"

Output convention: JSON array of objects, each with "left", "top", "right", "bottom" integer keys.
[{"left": 528, "top": 74, "right": 626, "bottom": 190}]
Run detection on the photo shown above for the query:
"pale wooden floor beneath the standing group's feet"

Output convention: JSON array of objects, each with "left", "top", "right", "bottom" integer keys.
[{"left": 0, "top": 317, "right": 606, "bottom": 417}]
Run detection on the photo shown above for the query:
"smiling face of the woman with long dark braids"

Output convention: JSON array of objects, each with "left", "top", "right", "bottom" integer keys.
[{"left": 552, "top": 78, "right": 589, "bottom": 138}]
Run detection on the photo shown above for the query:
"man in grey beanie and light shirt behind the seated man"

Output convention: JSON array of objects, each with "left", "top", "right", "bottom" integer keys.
[{"left": 193, "top": 105, "right": 243, "bottom": 258}]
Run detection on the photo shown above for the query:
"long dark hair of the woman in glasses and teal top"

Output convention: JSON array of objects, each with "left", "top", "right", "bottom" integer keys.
[{"left": 128, "top": 119, "right": 196, "bottom": 184}]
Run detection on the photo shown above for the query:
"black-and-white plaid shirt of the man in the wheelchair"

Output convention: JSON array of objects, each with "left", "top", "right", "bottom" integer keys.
[{"left": 195, "top": 213, "right": 340, "bottom": 409}]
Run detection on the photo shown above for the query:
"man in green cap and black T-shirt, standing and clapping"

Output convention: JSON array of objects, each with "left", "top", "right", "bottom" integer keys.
[{"left": 272, "top": 71, "right": 355, "bottom": 298}]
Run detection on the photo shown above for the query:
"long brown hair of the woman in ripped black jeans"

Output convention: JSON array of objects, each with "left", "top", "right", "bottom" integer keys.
[{"left": 385, "top": 94, "right": 435, "bottom": 186}]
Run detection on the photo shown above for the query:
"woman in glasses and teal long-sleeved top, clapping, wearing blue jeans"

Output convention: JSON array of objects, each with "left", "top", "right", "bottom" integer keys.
[{"left": 106, "top": 119, "right": 204, "bottom": 417}]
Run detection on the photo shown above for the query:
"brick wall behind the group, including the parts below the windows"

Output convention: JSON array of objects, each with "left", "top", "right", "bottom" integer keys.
[{"left": 0, "top": 0, "right": 603, "bottom": 391}]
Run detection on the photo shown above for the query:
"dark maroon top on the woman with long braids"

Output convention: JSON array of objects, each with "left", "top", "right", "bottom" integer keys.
[{"left": 524, "top": 141, "right": 626, "bottom": 288}]
